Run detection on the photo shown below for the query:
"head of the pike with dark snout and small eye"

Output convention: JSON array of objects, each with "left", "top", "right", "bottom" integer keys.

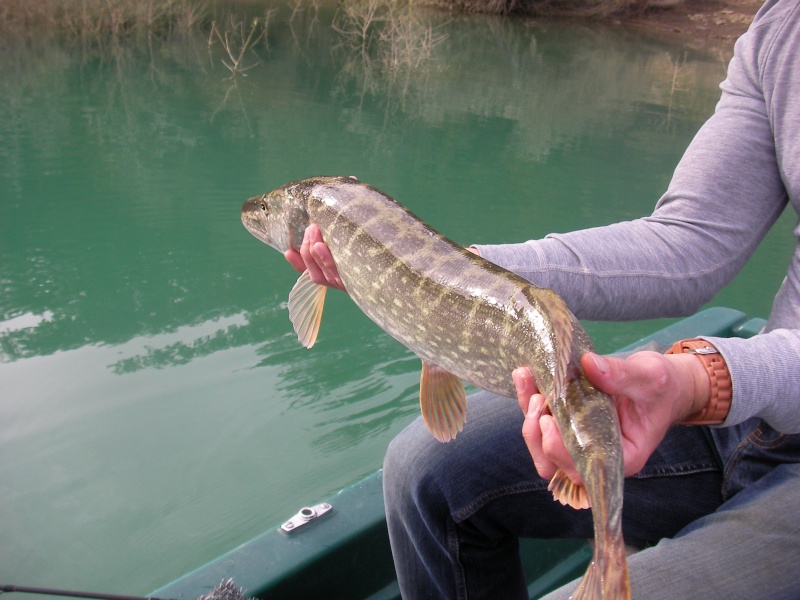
[{"left": 242, "top": 186, "right": 308, "bottom": 253}]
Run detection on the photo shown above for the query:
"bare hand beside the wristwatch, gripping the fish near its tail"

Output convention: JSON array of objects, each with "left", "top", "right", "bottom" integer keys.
[{"left": 513, "top": 352, "right": 710, "bottom": 483}]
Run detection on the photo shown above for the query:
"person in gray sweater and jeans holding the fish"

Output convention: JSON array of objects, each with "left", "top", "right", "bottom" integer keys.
[{"left": 286, "top": 0, "right": 800, "bottom": 600}]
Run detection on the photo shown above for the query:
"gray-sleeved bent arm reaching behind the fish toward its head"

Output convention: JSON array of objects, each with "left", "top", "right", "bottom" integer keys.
[{"left": 478, "top": 9, "right": 787, "bottom": 320}]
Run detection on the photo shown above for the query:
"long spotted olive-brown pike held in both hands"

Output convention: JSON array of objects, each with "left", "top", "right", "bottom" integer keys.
[{"left": 241, "top": 176, "right": 630, "bottom": 600}]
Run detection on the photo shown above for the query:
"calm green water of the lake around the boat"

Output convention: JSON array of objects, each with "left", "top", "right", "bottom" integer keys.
[{"left": 0, "top": 7, "right": 793, "bottom": 593}]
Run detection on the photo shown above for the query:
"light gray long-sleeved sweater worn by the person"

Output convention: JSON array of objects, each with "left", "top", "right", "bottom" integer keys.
[{"left": 478, "top": 0, "right": 800, "bottom": 433}]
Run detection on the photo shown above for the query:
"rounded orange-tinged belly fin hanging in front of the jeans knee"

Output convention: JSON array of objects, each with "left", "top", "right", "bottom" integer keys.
[{"left": 419, "top": 361, "right": 467, "bottom": 442}]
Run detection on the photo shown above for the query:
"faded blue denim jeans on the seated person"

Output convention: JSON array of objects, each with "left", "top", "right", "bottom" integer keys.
[{"left": 383, "top": 392, "right": 800, "bottom": 600}]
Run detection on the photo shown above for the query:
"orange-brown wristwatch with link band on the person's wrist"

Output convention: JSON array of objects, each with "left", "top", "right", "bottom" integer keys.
[{"left": 665, "top": 339, "right": 733, "bottom": 425}]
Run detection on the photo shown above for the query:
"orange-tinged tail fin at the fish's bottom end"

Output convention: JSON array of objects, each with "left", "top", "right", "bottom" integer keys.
[{"left": 570, "top": 536, "right": 631, "bottom": 600}]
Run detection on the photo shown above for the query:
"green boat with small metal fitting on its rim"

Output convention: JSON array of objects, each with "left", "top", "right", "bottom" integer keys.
[{"left": 150, "top": 307, "right": 764, "bottom": 600}]
